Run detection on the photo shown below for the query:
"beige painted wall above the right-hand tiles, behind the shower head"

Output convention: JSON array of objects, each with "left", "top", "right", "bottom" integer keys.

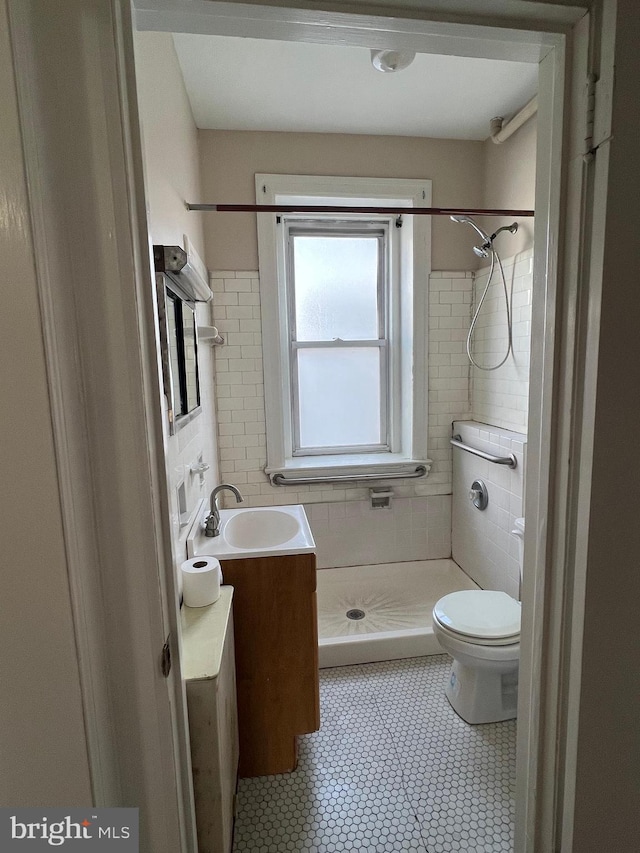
[{"left": 479, "top": 114, "right": 537, "bottom": 266}]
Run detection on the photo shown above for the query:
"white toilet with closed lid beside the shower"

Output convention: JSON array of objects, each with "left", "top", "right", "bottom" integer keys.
[{"left": 433, "top": 518, "right": 524, "bottom": 723}]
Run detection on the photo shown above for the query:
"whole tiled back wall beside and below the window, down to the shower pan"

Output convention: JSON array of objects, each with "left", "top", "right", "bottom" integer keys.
[{"left": 211, "top": 270, "right": 473, "bottom": 566}]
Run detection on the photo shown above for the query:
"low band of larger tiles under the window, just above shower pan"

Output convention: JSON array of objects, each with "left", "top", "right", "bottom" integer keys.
[{"left": 305, "top": 495, "right": 451, "bottom": 569}]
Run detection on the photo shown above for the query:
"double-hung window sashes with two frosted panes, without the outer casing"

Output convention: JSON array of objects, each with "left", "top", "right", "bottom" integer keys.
[{"left": 284, "top": 220, "right": 393, "bottom": 457}]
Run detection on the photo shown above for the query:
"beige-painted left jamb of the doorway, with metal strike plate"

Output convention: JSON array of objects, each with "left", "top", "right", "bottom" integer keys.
[{"left": 8, "top": 0, "right": 197, "bottom": 853}]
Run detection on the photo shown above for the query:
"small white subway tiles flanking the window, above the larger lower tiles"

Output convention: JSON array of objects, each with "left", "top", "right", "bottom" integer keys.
[{"left": 210, "top": 270, "right": 473, "bottom": 506}]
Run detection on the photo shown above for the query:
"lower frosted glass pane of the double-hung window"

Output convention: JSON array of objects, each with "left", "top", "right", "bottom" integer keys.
[{"left": 298, "top": 347, "right": 382, "bottom": 448}]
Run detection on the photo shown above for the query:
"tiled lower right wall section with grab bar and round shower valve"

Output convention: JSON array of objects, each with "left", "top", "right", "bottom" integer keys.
[{"left": 452, "top": 421, "right": 527, "bottom": 598}]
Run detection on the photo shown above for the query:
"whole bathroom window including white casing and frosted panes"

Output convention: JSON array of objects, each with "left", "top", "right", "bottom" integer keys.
[{"left": 256, "top": 175, "right": 430, "bottom": 479}]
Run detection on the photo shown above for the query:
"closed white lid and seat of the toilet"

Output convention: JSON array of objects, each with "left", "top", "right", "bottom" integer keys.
[{"left": 433, "top": 589, "right": 520, "bottom": 640}]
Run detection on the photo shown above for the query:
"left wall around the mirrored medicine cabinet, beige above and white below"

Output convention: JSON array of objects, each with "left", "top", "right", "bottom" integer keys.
[{"left": 135, "top": 32, "right": 218, "bottom": 578}]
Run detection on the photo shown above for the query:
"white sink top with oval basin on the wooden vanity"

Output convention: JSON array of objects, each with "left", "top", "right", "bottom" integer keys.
[{"left": 187, "top": 501, "right": 316, "bottom": 560}]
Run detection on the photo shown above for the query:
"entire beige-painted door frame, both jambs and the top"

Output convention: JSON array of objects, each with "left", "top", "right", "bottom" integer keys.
[{"left": 9, "top": 0, "right": 615, "bottom": 853}]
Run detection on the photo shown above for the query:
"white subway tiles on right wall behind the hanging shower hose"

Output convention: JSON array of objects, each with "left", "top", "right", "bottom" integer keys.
[{"left": 471, "top": 249, "right": 533, "bottom": 432}]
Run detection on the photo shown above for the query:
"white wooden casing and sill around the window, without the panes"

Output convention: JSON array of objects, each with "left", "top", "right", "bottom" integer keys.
[{"left": 256, "top": 174, "right": 431, "bottom": 478}]
